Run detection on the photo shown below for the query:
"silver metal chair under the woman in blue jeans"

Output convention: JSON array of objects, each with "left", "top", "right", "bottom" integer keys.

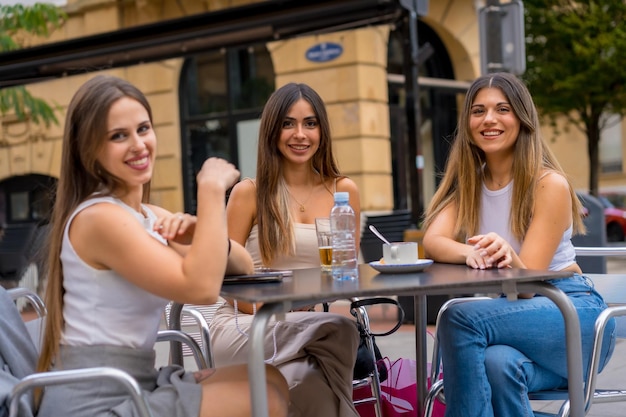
[{"left": 424, "top": 247, "right": 626, "bottom": 417}]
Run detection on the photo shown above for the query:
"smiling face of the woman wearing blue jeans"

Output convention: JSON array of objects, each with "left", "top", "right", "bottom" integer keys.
[{"left": 469, "top": 88, "right": 520, "bottom": 154}]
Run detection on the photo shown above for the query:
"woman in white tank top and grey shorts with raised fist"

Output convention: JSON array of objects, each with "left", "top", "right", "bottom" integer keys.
[{"left": 37, "top": 75, "right": 289, "bottom": 417}]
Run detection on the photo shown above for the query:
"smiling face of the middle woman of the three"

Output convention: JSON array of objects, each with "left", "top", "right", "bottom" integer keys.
[{"left": 278, "top": 99, "right": 320, "bottom": 163}]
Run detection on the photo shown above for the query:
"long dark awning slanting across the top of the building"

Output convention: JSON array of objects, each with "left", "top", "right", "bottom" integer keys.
[{"left": 0, "top": 0, "right": 403, "bottom": 88}]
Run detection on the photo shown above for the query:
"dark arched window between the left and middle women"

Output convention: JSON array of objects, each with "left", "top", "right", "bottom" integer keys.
[{"left": 179, "top": 44, "right": 274, "bottom": 213}]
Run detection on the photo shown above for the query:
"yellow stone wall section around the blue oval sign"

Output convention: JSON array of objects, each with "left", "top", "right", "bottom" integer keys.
[{"left": 268, "top": 27, "right": 393, "bottom": 211}]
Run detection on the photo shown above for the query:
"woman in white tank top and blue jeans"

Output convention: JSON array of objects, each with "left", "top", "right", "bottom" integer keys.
[{"left": 423, "top": 73, "right": 615, "bottom": 417}]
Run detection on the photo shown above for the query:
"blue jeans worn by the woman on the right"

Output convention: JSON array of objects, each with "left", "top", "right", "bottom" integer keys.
[{"left": 437, "top": 274, "right": 615, "bottom": 417}]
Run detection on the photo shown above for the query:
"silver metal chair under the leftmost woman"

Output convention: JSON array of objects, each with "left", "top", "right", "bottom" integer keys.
[{"left": 6, "top": 287, "right": 206, "bottom": 417}]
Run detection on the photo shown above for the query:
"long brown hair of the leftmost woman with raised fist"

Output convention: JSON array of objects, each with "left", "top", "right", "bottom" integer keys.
[{"left": 37, "top": 75, "right": 152, "bottom": 371}]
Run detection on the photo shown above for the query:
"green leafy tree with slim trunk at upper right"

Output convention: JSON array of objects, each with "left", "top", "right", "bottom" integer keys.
[{"left": 523, "top": 0, "right": 626, "bottom": 195}]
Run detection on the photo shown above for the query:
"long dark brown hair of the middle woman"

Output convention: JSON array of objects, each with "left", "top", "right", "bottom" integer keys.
[{"left": 256, "top": 83, "right": 341, "bottom": 265}]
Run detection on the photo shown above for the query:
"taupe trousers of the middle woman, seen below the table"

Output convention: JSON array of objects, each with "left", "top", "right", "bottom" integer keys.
[{"left": 210, "top": 303, "right": 359, "bottom": 417}]
